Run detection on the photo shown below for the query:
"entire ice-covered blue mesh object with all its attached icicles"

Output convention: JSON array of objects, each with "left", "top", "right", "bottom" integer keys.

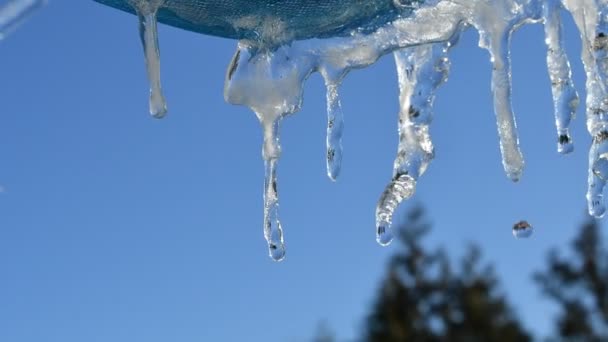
[{"left": 96, "top": 0, "right": 608, "bottom": 260}]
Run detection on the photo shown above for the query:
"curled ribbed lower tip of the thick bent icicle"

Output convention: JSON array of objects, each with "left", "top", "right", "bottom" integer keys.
[{"left": 376, "top": 174, "right": 416, "bottom": 246}]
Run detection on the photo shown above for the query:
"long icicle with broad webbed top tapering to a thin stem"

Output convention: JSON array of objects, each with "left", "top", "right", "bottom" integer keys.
[{"left": 224, "top": 42, "right": 310, "bottom": 261}]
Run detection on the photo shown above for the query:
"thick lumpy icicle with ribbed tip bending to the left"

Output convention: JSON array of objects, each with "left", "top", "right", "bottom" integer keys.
[{"left": 376, "top": 43, "right": 451, "bottom": 246}]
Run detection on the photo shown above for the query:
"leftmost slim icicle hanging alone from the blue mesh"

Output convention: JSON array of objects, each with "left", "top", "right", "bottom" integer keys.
[{"left": 129, "top": 0, "right": 167, "bottom": 119}]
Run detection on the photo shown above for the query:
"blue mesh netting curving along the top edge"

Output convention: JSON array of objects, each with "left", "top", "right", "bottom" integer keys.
[{"left": 95, "top": 0, "right": 418, "bottom": 39}]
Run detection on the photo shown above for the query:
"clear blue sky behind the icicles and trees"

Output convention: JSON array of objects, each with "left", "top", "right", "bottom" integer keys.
[{"left": 0, "top": 0, "right": 590, "bottom": 342}]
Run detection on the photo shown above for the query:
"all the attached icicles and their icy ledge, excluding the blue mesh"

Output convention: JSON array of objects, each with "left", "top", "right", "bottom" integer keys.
[{"left": 131, "top": 0, "right": 608, "bottom": 261}]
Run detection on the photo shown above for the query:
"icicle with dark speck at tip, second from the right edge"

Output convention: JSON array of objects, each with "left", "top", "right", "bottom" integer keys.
[{"left": 543, "top": 0, "right": 579, "bottom": 154}]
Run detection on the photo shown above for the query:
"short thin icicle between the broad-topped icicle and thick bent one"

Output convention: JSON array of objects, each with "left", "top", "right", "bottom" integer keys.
[{"left": 325, "top": 79, "right": 344, "bottom": 181}]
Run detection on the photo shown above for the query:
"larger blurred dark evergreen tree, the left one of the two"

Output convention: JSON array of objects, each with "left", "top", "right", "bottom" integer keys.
[{"left": 363, "top": 207, "right": 531, "bottom": 342}]
